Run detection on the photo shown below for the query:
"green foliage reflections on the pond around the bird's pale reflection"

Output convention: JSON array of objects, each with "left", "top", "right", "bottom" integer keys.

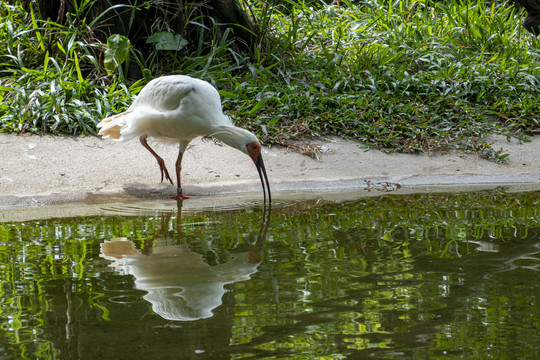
[{"left": 0, "top": 191, "right": 540, "bottom": 358}]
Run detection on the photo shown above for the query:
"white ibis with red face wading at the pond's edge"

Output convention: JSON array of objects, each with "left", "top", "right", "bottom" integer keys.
[{"left": 97, "top": 75, "right": 272, "bottom": 203}]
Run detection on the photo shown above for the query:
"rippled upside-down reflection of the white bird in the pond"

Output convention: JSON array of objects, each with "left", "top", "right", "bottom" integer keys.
[{"left": 101, "top": 207, "right": 270, "bottom": 321}]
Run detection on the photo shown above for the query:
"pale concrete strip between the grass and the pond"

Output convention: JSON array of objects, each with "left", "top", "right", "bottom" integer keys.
[{"left": 0, "top": 134, "right": 540, "bottom": 211}]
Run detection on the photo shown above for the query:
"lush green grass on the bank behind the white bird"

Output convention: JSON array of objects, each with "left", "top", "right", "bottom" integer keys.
[{"left": 0, "top": 0, "right": 540, "bottom": 162}]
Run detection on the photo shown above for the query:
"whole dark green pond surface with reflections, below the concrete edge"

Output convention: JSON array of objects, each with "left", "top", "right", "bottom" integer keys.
[{"left": 0, "top": 190, "right": 540, "bottom": 359}]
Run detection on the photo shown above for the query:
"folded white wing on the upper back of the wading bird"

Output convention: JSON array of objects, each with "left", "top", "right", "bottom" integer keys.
[{"left": 130, "top": 76, "right": 194, "bottom": 111}]
